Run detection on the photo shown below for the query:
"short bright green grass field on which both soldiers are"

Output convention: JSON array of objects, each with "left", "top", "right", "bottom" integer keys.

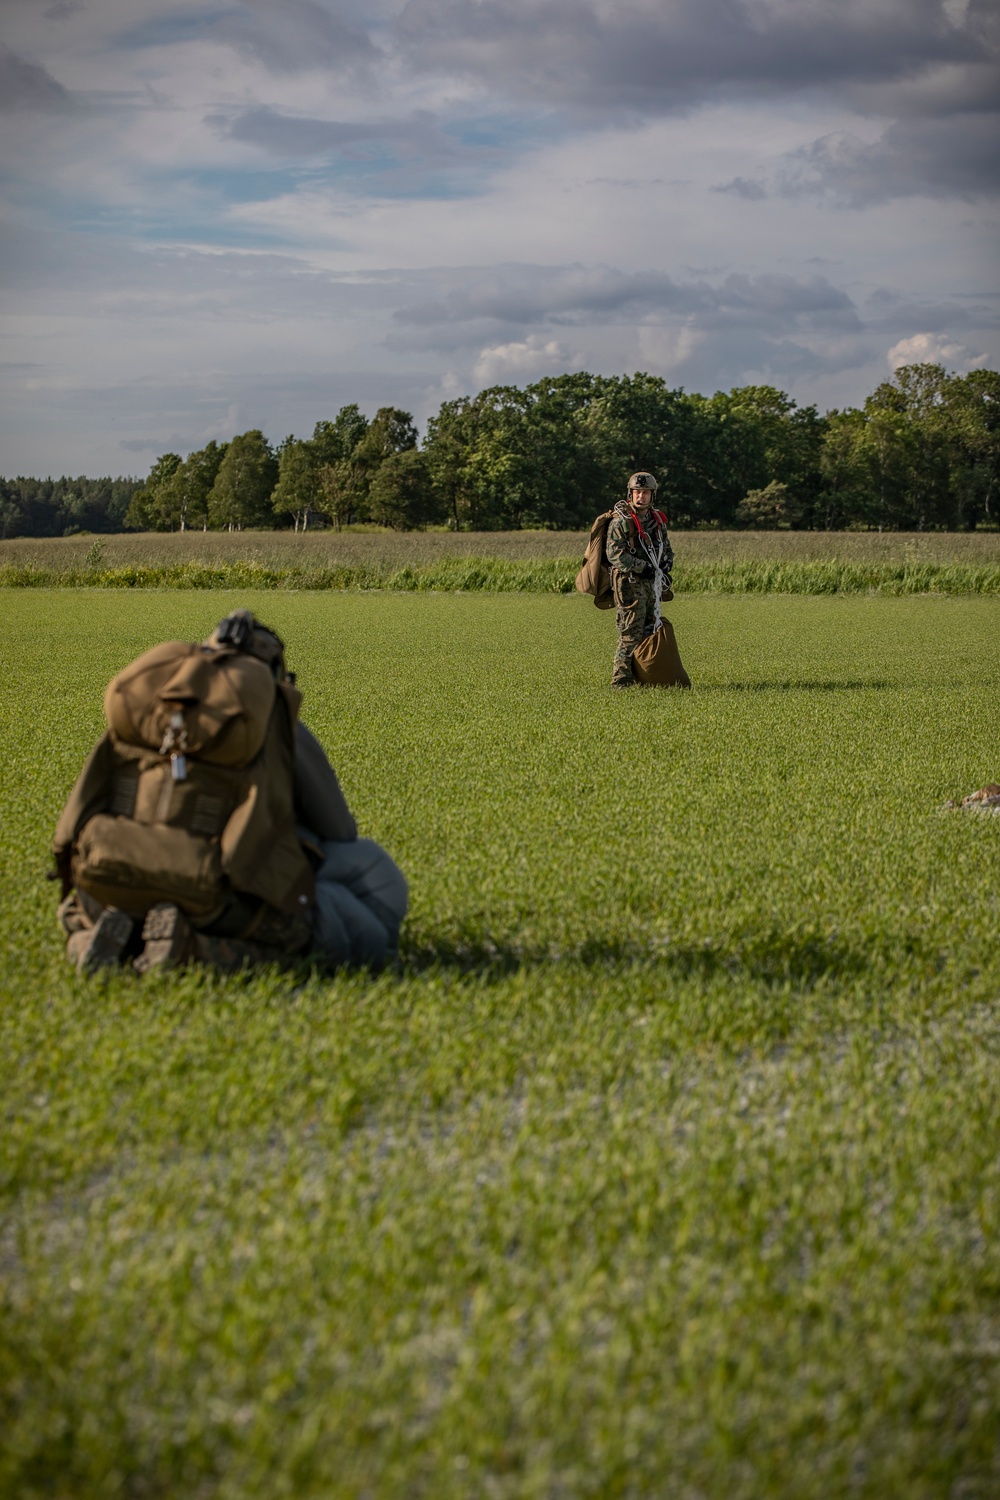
[{"left": 0, "top": 590, "right": 1000, "bottom": 1500}]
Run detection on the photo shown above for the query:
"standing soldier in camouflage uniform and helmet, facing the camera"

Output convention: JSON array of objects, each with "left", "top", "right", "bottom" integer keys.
[{"left": 607, "top": 471, "right": 673, "bottom": 687}]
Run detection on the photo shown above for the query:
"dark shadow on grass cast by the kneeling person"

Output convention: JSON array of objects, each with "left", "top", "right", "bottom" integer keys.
[{"left": 399, "top": 930, "right": 876, "bottom": 989}]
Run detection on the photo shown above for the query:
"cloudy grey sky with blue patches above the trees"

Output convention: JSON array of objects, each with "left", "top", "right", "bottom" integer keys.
[{"left": 0, "top": 0, "right": 1000, "bottom": 476}]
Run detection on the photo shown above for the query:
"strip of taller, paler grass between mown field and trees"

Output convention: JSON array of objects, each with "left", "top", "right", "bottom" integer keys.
[{"left": 0, "top": 528, "right": 1000, "bottom": 596}]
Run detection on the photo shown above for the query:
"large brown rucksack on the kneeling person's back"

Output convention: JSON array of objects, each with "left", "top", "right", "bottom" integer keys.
[{"left": 54, "top": 641, "right": 315, "bottom": 924}]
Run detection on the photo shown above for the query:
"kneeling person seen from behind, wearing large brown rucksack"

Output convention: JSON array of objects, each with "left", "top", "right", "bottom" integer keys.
[{"left": 54, "top": 611, "right": 408, "bottom": 972}]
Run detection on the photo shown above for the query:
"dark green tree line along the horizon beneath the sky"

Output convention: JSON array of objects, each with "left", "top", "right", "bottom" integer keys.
[{"left": 0, "top": 365, "right": 1000, "bottom": 536}]
